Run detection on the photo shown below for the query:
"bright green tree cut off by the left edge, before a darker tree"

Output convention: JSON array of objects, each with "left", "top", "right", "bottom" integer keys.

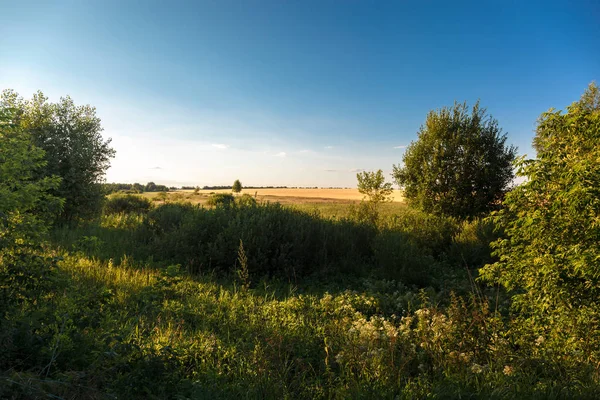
[{"left": 0, "top": 105, "right": 62, "bottom": 312}]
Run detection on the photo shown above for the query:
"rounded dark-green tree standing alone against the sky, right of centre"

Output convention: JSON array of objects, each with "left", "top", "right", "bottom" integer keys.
[{"left": 393, "top": 102, "right": 516, "bottom": 218}]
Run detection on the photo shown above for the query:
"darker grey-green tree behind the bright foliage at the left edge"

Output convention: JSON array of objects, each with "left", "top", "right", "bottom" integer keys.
[{"left": 1, "top": 90, "right": 115, "bottom": 221}]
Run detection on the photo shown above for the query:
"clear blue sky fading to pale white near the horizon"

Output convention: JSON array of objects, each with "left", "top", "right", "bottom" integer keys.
[{"left": 0, "top": 0, "right": 600, "bottom": 186}]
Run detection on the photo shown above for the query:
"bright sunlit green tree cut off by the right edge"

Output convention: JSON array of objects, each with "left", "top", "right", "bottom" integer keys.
[{"left": 480, "top": 84, "right": 600, "bottom": 365}]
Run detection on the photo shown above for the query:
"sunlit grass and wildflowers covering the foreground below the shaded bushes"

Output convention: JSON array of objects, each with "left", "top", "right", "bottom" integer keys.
[{"left": 0, "top": 253, "right": 599, "bottom": 399}]
